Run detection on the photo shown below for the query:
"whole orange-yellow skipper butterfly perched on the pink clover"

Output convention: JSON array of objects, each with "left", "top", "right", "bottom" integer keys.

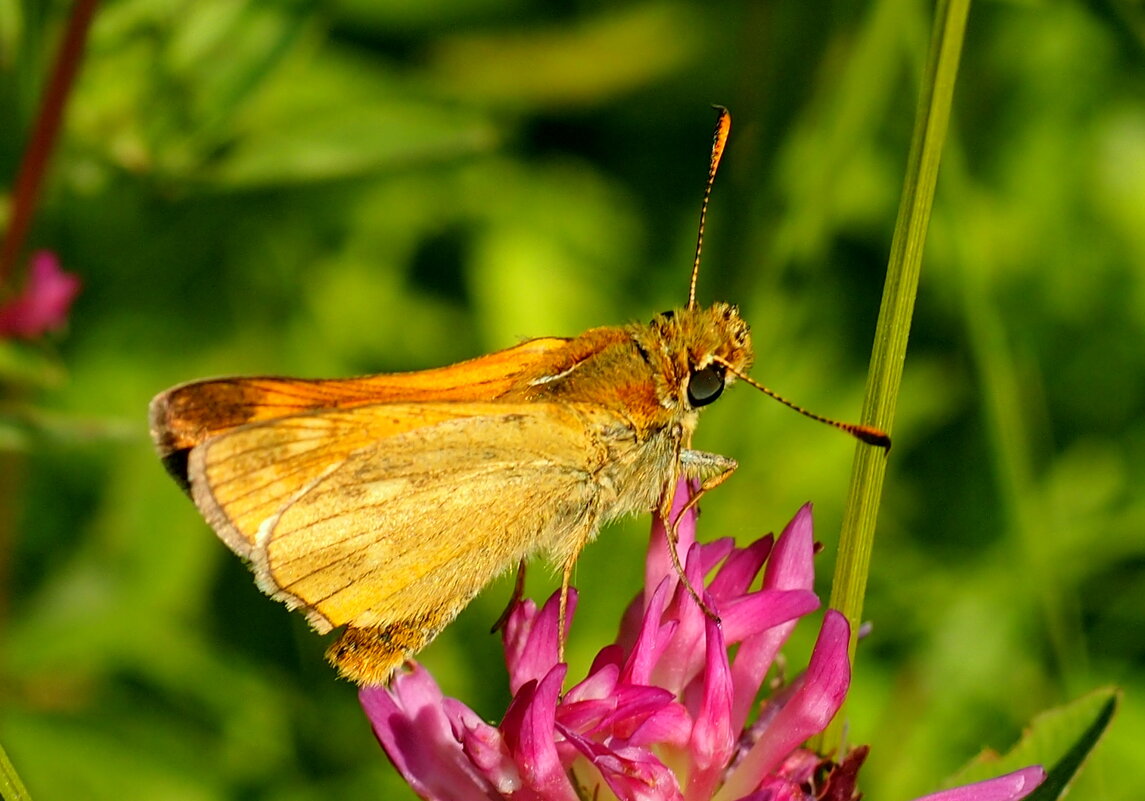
[{"left": 150, "top": 109, "right": 890, "bottom": 684}]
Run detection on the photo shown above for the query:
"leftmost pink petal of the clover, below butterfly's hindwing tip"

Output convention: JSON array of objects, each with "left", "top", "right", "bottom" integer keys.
[{"left": 358, "top": 665, "right": 496, "bottom": 801}]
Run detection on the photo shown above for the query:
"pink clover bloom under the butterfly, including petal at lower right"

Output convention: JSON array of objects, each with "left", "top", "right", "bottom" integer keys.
[{"left": 361, "top": 483, "right": 1044, "bottom": 801}]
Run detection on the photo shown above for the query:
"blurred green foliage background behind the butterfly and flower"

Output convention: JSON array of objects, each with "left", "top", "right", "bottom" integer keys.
[{"left": 0, "top": 0, "right": 1145, "bottom": 801}]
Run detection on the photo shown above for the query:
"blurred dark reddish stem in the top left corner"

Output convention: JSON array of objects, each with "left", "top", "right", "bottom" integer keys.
[{"left": 0, "top": 0, "right": 98, "bottom": 293}]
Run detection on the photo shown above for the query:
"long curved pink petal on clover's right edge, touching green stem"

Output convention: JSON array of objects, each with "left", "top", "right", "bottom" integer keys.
[{"left": 717, "top": 609, "right": 851, "bottom": 799}]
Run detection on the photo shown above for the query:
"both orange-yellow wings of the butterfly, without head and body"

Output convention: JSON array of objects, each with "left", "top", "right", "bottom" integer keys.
[{"left": 151, "top": 328, "right": 655, "bottom": 683}]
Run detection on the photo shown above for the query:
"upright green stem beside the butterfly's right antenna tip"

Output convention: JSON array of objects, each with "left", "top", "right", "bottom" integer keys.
[{"left": 823, "top": 0, "right": 970, "bottom": 744}]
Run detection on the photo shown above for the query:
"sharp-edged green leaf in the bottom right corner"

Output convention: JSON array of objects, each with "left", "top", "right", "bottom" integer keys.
[{"left": 949, "top": 687, "right": 1121, "bottom": 801}]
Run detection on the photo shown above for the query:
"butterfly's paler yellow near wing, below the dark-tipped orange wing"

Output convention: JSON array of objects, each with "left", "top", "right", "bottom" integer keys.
[{"left": 189, "top": 403, "right": 621, "bottom": 683}]
